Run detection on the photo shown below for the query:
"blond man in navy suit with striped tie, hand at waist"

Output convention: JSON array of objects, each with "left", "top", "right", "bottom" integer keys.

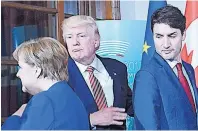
[{"left": 62, "top": 15, "right": 133, "bottom": 130}]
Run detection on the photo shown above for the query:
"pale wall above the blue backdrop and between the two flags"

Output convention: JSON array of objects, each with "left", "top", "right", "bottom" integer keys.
[{"left": 120, "top": 0, "right": 186, "bottom": 20}]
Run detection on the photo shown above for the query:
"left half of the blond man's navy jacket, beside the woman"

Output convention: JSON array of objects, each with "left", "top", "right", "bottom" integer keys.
[{"left": 68, "top": 58, "right": 98, "bottom": 113}]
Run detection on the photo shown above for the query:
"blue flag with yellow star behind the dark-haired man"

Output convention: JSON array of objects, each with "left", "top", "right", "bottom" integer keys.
[{"left": 141, "top": 0, "right": 167, "bottom": 65}]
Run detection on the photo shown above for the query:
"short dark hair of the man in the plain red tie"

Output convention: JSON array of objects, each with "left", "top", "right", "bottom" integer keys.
[{"left": 151, "top": 5, "right": 186, "bottom": 34}]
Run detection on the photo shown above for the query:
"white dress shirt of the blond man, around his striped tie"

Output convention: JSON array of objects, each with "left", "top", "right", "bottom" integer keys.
[{"left": 75, "top": 57, "right": 114, "bottom": 107}]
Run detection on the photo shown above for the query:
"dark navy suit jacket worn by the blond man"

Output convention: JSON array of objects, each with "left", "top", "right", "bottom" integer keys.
[{"left": 68, "top": 56, "right": 133, "bottom": 130}]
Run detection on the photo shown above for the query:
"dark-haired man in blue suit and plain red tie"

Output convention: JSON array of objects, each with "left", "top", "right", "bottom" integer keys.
[{"left": 133, "top": 5, "right": 198, "bottom": 130}]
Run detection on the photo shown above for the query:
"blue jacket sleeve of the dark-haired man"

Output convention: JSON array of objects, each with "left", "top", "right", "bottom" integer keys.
[{"left": 133, "top": 71, "right": 161, "bottom": 130}]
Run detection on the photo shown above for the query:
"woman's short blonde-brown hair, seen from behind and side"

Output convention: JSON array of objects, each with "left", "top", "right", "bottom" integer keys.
[{"left": 13, "top": 37, "right": 68, "bottom": 81}]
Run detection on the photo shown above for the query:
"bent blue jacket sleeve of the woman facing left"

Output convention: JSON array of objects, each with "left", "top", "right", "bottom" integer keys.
[{"left": 3, "top": 94, "right": 54, "bottom": 130}]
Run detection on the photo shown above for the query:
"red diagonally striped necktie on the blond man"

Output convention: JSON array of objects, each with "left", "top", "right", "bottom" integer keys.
[{"left": 86, "top": 66, "right": 107, "bottom": 110}]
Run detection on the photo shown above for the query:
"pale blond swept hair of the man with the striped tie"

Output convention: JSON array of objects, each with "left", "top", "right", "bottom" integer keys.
[{"left": 62, "top": 15, "right": 100, "bottom": 41}]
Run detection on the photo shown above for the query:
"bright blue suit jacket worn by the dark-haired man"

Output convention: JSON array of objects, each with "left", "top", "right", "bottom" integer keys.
[{"left": 133, "top": 53, "right": 198, "bottom": 130}]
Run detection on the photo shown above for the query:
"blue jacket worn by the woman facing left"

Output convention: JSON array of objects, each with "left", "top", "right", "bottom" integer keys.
[{"left": 2, "top": 81, "right": 89, "bottom": 130}]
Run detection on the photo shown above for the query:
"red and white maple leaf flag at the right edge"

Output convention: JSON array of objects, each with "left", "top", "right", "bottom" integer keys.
[{"left": 181, "top": 0, "right": 198, "bottom": 87}]
